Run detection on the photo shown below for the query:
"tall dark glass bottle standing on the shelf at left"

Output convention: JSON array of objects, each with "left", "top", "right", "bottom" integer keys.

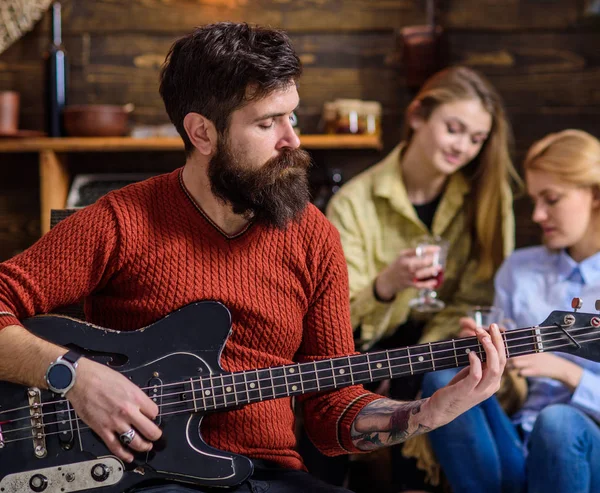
[{"left": 45, "top": 2, "right": 67, "bottom": 137}]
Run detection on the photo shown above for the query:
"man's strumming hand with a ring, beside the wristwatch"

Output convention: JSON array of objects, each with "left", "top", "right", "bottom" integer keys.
[{"left": 67, "top": 358, "right": 162, "bottom": 462}]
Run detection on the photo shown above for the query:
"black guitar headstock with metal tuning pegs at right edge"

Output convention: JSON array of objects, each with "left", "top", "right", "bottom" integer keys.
[{"left": 539, "top": 298, "right": 600, "bottom": 361}]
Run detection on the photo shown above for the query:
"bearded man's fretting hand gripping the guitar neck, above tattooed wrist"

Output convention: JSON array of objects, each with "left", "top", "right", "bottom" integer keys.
[{"left": 427, "top": 324, "right": 506, "bottom": 428}]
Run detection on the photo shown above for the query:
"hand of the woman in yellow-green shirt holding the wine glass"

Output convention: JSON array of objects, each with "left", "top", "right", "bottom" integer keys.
[{"left": 375, "top": 246, "right": 440, "bottom": 300}]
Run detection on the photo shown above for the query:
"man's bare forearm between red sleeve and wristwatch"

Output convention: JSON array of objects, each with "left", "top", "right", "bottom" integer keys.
[{"left": 0, "top": 325, "right": 65, "bottom": 388}]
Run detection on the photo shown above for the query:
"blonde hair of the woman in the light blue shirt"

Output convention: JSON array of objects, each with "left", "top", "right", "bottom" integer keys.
[{"left": 523, "top": 129, "right": 600, "bottom": 189}]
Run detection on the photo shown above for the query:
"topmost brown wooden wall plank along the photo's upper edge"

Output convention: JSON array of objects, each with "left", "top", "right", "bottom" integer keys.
[{"left": 35, "top": 0, "right": 583, "bottom": 33}]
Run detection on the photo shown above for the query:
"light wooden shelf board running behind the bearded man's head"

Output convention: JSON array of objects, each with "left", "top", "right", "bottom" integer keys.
[{"left": 0, "top": 134, "right": 381, "bottom": 152}]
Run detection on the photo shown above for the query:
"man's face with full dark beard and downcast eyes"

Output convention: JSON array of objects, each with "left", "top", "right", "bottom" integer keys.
[{"left": 209, "top": 84, "right": 310, "bottom": 228}]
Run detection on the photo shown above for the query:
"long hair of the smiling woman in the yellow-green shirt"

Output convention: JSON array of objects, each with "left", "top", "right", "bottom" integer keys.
[{"left": 403, "top": 67, "right": 522, "bottom": 279}]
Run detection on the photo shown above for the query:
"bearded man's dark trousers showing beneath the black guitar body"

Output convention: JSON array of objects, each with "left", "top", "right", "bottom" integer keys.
[{"left": 136, "top": 468, "right": 352, "bottom": 493}]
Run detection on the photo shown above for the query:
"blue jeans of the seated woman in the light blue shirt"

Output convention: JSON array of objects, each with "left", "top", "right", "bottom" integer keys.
[{"left": 423, "top": 370, "right": 600, "bottom": 493}]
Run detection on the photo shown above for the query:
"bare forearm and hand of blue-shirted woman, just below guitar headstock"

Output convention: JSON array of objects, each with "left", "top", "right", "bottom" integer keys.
[{"left": 507, "top": 353, "right": 583, "bottom": 392}]
